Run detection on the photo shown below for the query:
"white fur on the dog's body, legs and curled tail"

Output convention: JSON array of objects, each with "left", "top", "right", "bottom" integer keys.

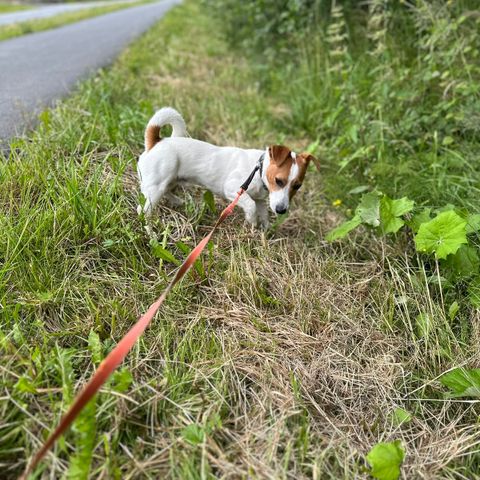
[{"left": 138, "top": 107, "right": 282, "bottom": 228}]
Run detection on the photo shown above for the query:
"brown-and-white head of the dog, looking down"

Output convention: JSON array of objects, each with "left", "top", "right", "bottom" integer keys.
[{"left": 264, "top": 145, "right": 319, "bottom": 214}]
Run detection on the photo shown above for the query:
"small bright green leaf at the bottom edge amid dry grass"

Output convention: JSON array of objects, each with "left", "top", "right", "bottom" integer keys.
[{"left": 367, "top": 440, "right": 405, "bottom": 480}]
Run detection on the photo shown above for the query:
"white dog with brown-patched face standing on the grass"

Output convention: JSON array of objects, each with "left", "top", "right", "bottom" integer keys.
[{"left": 138, "top": 107, "right": 319, "bottom": 229}]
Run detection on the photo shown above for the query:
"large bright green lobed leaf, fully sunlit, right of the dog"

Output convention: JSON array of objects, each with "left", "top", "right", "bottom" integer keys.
[{"left": 415, "top": 210, "right": 467, "bottom": 258}]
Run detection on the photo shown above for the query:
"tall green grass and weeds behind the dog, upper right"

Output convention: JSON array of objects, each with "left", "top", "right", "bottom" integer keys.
[{"left": 210, "top": 0, "right": 480, "bottom": 210}]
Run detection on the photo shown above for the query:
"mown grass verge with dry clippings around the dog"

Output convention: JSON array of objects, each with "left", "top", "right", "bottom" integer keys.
[{"left": 0, "top": 2, "right": 480, "bottom": 479}]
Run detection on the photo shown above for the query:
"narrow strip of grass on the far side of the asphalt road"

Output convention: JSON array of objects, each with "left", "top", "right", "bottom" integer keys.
[{"left": 0, "top": 0, "right": 152, "bottom": 41}]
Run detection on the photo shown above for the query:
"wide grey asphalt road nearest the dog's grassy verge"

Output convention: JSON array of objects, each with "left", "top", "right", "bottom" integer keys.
[{"left": 0, "top": 0, "right": 180, "bottom": 142}]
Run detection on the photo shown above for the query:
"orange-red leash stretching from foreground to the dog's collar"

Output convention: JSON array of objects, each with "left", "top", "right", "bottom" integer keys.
[{"left": 19, "top": 158, "right": 265, "bottom": 480}]
